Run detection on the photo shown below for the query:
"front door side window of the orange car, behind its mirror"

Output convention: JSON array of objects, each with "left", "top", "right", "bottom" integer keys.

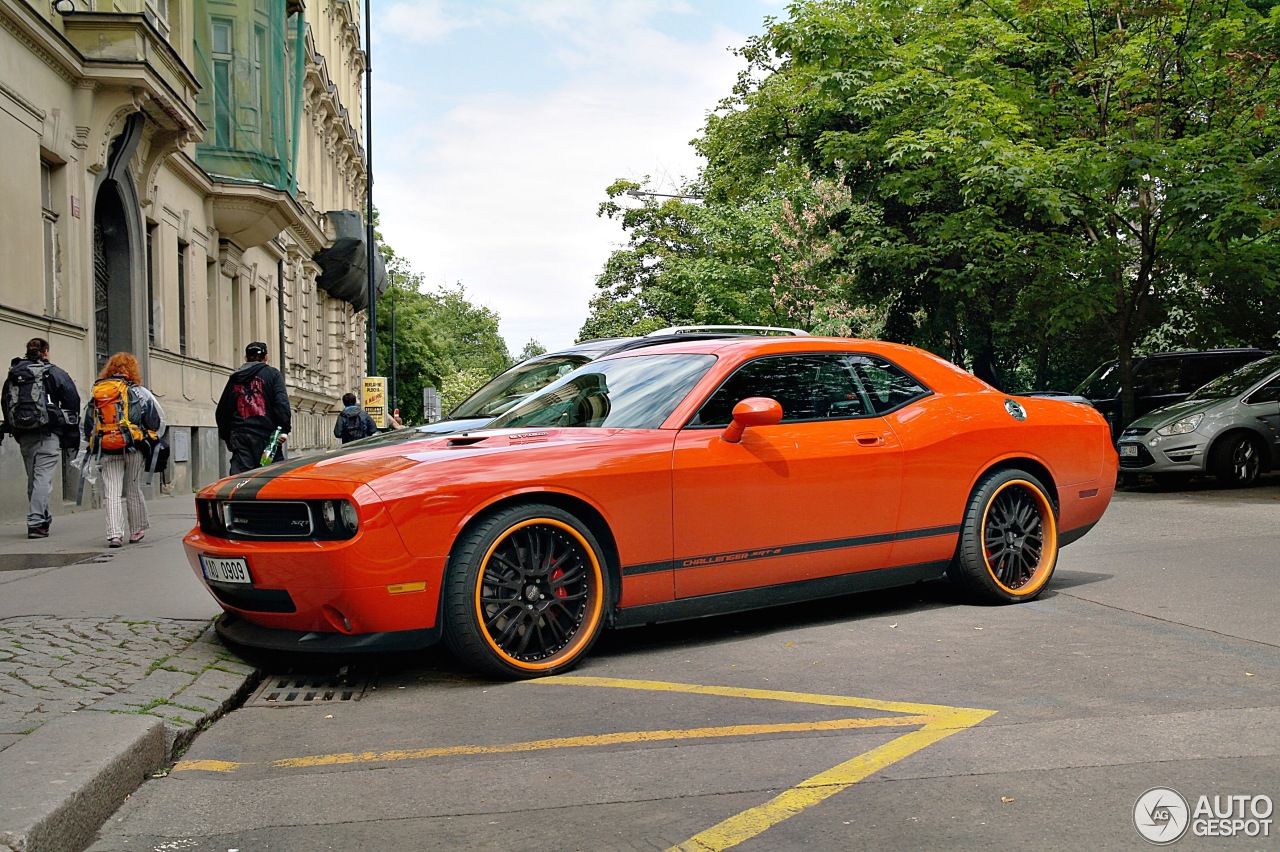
[{"left": 690, "top": 353, "right": 870, "bottom": 426}]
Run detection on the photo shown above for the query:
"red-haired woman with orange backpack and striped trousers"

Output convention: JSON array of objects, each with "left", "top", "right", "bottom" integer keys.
[{"left": 84, "top": 352, "right": 164, "bottom": 548}]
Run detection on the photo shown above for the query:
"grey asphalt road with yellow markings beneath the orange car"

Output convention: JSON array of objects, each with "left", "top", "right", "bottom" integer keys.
[{"left": 92, "top": 476, "right": 1280, "bottom": 852}]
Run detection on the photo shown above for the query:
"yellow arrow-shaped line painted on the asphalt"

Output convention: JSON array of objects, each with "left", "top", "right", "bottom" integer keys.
[{"left": 174, "top": 675, "right": 996, "bottom": 852}]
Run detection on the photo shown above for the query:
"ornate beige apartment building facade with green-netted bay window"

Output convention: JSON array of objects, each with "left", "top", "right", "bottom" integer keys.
[{"left": 0, "top": 0, "right": 385, "bottom": 521}]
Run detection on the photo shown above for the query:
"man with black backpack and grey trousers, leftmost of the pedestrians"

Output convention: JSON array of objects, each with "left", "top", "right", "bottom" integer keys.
[{"left": 0, "top": 338, "right": 79, "bottom": 539}]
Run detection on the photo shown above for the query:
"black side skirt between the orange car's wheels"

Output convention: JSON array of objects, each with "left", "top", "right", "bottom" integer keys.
[{"left": 612, "top": 560, "right": 950, "bottom": 627}]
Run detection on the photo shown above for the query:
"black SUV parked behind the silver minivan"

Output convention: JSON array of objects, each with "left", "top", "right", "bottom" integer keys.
[{"left": 1075, "top": 349, "right": 1271, "bottom": 438}]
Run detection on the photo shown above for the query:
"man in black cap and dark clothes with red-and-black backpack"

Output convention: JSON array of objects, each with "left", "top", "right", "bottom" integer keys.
[{"left": 215, "top": 342, "right": 292, "bottom": 473}]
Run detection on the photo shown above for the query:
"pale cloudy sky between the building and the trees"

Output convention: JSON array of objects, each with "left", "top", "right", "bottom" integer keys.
[{"left": 371, "top": 0, "right": 785, "bottom": 356}]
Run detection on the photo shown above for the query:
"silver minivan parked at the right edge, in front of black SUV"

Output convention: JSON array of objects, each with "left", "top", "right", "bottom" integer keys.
[{"left": 1117, "top": 356, "right": 1280, "bottom": 486}]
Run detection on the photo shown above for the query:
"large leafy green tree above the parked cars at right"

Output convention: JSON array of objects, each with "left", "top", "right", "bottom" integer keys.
[{"left": 696, "top": 0, "right": 1280, "bottom": 414}]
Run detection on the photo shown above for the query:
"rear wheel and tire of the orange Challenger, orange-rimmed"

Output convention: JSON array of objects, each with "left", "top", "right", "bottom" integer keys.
[{"left": 947, "top": 469, "right": 1057, "bottom": 604}]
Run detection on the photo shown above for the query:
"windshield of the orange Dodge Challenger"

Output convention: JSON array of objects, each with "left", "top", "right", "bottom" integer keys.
[{"left": 489, "top": 354, "right": 716, "bottom": 429}]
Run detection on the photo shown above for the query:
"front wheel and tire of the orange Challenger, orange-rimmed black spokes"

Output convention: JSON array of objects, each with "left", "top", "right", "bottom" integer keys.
[{"left": 444, "top": 504, "right": 609, "bottom": 678}]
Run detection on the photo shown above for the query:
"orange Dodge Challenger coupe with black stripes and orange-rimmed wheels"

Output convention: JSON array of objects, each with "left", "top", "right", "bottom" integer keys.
[{"left": 184, "top": 336, "right": 1117, "bottom": 678}]
